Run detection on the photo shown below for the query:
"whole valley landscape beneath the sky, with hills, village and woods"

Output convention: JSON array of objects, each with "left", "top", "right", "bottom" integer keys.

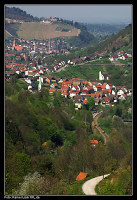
[{"left": 4, "top": 5, "right": 133, "bottom": 196}]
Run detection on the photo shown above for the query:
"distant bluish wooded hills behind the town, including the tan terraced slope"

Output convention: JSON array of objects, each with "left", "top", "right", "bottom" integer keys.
[{"left": 5, "top": 7, "right": 97, "bottom": 47}]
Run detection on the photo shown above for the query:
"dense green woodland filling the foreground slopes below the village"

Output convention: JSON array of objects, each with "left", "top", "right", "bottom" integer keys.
[{"left": 5, "top": 74, "right": 132, "bottom": 195}]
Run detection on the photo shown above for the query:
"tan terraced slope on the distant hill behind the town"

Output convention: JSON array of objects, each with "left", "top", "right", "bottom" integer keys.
[{"left": 17, "top": 22, "right": 80, "bottom": 40}]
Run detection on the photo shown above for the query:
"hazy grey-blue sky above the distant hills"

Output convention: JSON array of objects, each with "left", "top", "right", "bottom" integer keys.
[{"left": 6, "top": 4, "right": 132, "bottom": 23}]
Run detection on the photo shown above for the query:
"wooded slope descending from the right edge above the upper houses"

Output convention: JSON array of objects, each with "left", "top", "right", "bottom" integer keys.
[{"left": 53, "top": 24, "right": 132, "bottom": 59}]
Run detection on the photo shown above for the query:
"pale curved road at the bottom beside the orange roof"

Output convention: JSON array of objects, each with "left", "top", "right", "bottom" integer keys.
[{"left": 82, "top": 174, "right": 109, "bottom": 195}]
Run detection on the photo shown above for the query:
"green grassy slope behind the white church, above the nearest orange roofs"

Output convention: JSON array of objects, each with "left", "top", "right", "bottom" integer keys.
[{"left": 51, "top": 64, "right": 132, "bottom": 88}]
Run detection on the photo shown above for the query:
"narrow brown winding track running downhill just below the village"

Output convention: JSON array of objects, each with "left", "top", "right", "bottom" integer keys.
[{"left": 92, "top": 111, "right": 109, "bottom": 145}]
